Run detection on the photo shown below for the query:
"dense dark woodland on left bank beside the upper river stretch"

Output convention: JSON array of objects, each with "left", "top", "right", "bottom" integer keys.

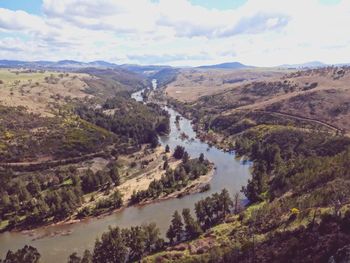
[{"left": 75, "top": 96, "right": 169, "bottom": 147}]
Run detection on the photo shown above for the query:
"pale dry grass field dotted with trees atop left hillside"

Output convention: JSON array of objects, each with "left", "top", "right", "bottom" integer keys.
[{"left": 0, "top": 69, "right": 93, "bottom": 116}]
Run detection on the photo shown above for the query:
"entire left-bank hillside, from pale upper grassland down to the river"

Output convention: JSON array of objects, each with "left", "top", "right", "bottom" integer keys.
[{"left": 0, "top": 66, "right": 168, "bottom": 235}]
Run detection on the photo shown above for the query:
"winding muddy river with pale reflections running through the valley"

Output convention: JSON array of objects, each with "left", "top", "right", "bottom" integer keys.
[{"left": 0, "top": 80, "right": 250, "bottom": 263}]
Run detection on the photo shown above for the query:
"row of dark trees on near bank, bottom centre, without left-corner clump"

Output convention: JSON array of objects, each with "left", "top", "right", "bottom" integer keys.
[{"left": 64, "top": 190, "right": 232, "bottom": 263}]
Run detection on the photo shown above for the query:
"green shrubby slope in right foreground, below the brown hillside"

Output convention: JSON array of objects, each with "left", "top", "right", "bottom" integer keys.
[{"left": 145, "top": 124, "right": 350, "bottom": 263}]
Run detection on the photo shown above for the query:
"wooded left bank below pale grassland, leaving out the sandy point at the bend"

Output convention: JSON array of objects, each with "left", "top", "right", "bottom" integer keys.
[{"left": 0, "top": 87, "right": 169, "bottom": 231}]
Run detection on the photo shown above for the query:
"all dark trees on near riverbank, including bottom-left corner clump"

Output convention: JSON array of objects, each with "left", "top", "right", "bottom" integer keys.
[{"left": 0, "top": 189, "right": 237, "bottom": 263}]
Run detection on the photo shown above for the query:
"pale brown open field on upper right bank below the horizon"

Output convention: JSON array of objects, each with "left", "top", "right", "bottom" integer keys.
[{"left": 166, "top": 67, "right": 350, "bottom": 131}]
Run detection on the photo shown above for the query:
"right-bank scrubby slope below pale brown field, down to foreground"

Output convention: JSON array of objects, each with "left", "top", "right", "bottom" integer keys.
[{"left": 144, "top": 67, "right": 350, "bottom": 262}]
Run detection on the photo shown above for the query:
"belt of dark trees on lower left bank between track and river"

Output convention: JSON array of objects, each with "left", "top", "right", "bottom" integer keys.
[{"left": 0, "top": 163, "right": 122, "bottom": 232}]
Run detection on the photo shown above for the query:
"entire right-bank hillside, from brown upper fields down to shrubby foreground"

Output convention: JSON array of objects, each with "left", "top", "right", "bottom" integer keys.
[{"left": 139, "top": 67, "right": 350, "bottom": 263}]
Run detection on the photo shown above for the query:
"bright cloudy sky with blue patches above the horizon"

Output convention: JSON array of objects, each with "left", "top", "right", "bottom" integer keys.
[{"left": 0, "top": 0, "right": 350, "bottom": 66}]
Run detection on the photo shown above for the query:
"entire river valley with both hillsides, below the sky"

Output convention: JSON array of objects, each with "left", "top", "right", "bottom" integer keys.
[{"left": 0, "top": 64, "right": 350, "bottom": 262}]
